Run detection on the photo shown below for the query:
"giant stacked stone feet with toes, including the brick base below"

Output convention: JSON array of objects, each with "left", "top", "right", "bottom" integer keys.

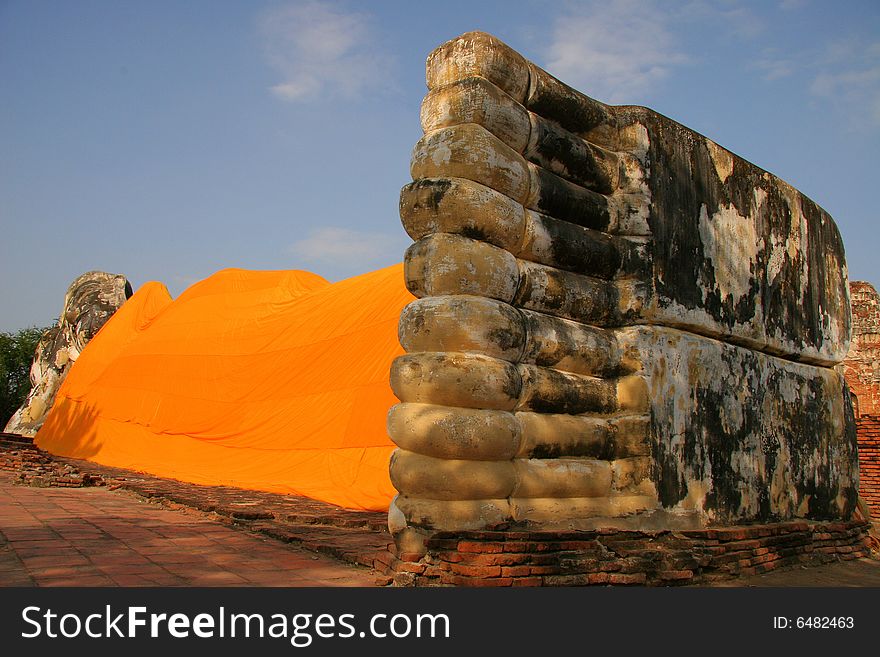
[{"left": 388, "top": 32, "right": 866, "bottom": 585}]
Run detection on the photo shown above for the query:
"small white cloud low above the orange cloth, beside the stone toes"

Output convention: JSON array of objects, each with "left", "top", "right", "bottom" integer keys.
[{"left": 288, "top": 227, "right": 408, "bottom": 268}]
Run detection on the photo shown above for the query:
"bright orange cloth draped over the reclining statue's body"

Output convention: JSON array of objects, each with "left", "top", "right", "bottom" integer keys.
[{"left": 36, "top": 264, "right": 413, "bottom": 510}]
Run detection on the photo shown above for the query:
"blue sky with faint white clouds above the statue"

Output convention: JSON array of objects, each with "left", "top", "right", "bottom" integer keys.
[{"left": 0, "top": 0, "right": 880, "bottom": 331}]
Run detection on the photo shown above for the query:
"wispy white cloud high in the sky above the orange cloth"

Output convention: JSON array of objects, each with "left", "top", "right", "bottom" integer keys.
[{"left": 258, "top": 0, "right": 392, "bottom": 102}]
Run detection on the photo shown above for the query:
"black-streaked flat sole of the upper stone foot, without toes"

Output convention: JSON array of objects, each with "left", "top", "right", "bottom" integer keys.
[{"left": 618, "top": 108, "right": 850, "bottom": 365}]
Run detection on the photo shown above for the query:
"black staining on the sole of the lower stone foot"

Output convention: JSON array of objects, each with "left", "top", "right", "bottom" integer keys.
[{"left": 654, "top": 348, "right": 858, "bottom": 524}]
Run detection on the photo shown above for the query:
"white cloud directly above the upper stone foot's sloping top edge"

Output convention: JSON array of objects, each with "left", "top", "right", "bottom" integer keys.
[{"left": 546, "top": 0, "right": 687, "bottom": 103}]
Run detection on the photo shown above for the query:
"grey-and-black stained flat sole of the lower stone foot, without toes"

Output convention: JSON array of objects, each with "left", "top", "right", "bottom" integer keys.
[{"left": 618, "top": 327, "right": 858, "bottom": 524}]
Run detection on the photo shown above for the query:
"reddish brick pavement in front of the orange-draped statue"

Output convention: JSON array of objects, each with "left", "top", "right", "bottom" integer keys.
[{"left": 0, "top": 472, "right": 382, "bottom": 586}]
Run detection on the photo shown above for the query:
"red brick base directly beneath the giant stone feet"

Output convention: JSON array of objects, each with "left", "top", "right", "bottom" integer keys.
[{"left": 391, "top": 521, "right": 870, "bottom": 586}]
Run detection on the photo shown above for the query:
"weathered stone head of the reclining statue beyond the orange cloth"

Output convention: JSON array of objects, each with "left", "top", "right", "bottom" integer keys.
[{"left": 5, "top": 271, "right": 132, "bottom": 436}]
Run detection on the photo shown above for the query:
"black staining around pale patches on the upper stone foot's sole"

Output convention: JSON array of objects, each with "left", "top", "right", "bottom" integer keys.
[{"left": 619, "top": 108, "right": 846, "bottom": 354}]
